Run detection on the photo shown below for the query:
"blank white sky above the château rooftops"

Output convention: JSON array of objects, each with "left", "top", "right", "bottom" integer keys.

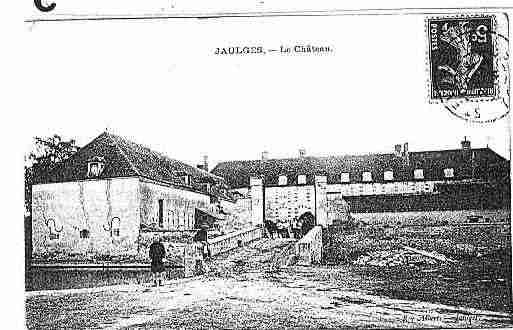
[{"left": 20, "top": 15, "right": 510, "bottom": 167}]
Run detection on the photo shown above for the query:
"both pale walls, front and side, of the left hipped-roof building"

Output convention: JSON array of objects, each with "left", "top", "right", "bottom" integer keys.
[{"left": 32, "top": 178, "right": 214, "bottom": 264}]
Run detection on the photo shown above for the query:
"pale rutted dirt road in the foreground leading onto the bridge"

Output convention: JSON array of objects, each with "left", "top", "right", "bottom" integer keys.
[{"left": 27, "top": 240, "right": 511, "bottom": 329}]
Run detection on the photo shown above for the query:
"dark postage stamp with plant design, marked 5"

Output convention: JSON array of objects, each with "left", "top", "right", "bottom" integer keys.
[{"left": 427, "top": 16, "right": 497, "bottom": 101}]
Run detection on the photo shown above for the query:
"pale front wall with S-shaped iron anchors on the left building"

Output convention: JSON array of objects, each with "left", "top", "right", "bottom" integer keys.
[{"left": 32, "top": 178, "right": 140, "bottom": 261}]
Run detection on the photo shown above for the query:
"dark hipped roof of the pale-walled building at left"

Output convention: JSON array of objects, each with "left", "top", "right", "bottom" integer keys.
[{"left": 38, "top": 132, "right": 224, "bottom": 192}]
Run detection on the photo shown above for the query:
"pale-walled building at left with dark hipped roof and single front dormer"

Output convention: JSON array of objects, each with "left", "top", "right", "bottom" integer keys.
[{"left": 32, "top": 133, "right": 233, "bottom": 260}]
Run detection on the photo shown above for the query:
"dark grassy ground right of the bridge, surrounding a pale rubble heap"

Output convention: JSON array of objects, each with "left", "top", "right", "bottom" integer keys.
[{"left": 323, "top": 214, "right": 512, "bottom": 312}]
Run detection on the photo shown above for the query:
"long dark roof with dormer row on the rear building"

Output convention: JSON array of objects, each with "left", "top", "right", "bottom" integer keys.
[{"left": 211, "top": 148, "right": 509, "bottom": 188}]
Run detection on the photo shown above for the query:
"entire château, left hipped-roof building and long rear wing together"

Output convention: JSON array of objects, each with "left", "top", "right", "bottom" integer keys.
[{"left": 32, "top": 132, "right": 510, "bottom": 260}]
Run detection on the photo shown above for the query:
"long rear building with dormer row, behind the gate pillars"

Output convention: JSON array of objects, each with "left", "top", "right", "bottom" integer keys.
[{"left": 212, "top": 139, "right": 510, "bottom": 225}]
